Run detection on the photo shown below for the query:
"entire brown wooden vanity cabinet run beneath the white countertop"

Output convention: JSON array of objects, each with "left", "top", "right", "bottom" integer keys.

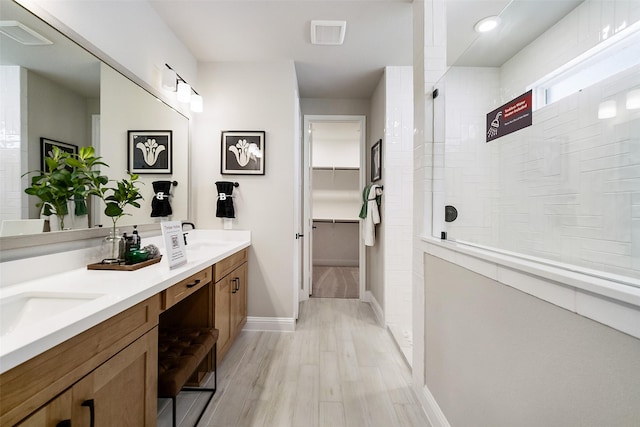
[{"left": 0, "top": 249, "right": 248, "bottom": 427}]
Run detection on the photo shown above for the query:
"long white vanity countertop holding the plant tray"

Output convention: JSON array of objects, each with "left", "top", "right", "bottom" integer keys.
[{"left": 0, "top": 229, "right": 251, "bottom": 373}]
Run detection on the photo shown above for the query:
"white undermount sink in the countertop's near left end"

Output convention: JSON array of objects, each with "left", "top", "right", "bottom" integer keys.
[{"left": 0, "top": 291, "right": 103, "bottom": 337}]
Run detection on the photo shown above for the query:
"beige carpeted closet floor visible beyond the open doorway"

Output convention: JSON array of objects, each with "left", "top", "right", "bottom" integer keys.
[{"left": 311, "top": 265, "right": 360, "bottom": 298}]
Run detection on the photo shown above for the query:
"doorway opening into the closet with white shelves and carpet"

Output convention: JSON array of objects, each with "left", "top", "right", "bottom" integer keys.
[{"left": 300, "top": 115, "right": 366, "bottom": 301}]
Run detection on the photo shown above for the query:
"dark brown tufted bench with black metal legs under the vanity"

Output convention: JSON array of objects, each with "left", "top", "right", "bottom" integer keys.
[{"left": 158, "top": 327, "right": 218, "bottom": 427}]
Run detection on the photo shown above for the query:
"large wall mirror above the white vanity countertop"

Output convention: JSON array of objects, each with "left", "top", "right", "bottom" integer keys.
[{"left": 0, "top": 0, "right": 189, "bottom": 248}]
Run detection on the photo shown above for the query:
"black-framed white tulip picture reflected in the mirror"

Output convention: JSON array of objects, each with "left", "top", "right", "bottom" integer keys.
[{"left": 127, "top": 130, "right": 173, "bottom": 174}]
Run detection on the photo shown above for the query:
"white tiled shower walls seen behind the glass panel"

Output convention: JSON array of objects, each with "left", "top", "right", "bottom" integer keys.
[{"left": 434, "top": 0, "right": 640, "bottom": 277}]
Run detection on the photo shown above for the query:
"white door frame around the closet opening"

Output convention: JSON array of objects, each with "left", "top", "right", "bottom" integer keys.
[{"left": 299, "top": 114, "right": 367, "bottom": 302}]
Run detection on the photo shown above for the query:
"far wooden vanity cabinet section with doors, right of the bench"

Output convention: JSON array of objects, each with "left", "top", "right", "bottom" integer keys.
[{"left": 214, "top": 249, "right": 248, "bottom": 361}]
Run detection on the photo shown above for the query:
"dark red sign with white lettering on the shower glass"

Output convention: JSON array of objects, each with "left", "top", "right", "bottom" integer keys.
[{"left": 486, "top": 91, "right": 533, "bottom": 142}]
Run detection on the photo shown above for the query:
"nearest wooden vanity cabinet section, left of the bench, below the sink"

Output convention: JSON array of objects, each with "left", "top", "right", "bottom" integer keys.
[{"left": 0, "top": 295, "right": 160, "bottom": 427}]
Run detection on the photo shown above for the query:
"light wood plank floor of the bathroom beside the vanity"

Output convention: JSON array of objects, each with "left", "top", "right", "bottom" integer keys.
[{"left": 158, "top": 299, "right": 430, "bottom": 427}]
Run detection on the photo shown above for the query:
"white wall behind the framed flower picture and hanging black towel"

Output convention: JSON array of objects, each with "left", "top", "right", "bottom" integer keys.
[{"left": 191, "top": 61, "right": 299, "bottom": 318}]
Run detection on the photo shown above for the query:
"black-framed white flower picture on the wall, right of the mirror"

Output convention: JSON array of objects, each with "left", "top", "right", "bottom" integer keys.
[{"left": 220, "top": 131, "right": 265, "bottom": 175}]
